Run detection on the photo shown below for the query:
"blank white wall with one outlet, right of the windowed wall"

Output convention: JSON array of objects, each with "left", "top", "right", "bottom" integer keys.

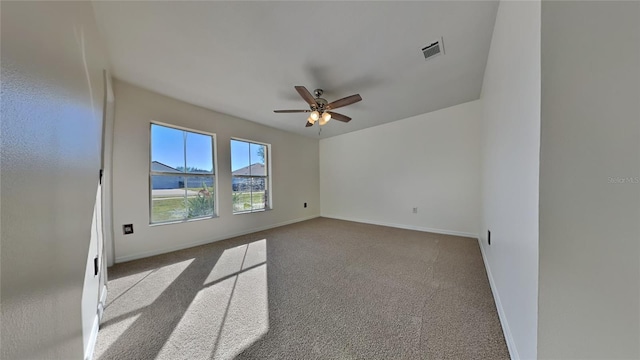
[{"left": 320, "top": 101, "right": 481, "bottom": 237}]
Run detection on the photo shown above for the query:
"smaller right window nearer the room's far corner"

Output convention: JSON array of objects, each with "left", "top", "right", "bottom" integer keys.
[{"left": 231, "top": 139, "right": 270, "bottom": 214}]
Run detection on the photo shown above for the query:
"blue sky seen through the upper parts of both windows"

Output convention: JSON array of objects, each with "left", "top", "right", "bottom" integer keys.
[{"left": 151, "top": 124, "right": 263, "bottom": 171}]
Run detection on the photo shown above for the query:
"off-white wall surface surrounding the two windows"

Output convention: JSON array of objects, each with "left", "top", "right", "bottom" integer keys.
[{"left": 113, "top": 81, "right": 320, "bottom": 262}]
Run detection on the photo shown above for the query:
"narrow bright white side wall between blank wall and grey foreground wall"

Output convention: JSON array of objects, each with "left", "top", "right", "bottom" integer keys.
[{"left": 480, "top": 1, "right": 540, "bottom": 359}]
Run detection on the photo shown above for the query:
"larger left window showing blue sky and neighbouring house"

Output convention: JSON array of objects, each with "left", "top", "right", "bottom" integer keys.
[{"left": 149, "top": 124, "right": 215, "bottom": 224}]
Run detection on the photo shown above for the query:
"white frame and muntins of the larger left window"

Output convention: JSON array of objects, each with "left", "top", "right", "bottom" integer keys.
[{"left": 147, "top": 121, "right": 219, "bottom": 226}]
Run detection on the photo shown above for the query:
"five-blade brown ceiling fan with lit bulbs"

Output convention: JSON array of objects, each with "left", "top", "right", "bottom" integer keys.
[{"left": 273, "top": 86, "right": 362, "bottom": 127}]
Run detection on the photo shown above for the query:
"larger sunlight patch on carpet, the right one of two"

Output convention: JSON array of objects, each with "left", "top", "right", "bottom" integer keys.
[{"left": 158, "top": 239, "right": 269, "bottom": 359}]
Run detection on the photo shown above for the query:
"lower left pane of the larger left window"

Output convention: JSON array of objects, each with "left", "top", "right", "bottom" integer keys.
[{"left": 151, "top": 175, "right": 187, "bottom": 223}]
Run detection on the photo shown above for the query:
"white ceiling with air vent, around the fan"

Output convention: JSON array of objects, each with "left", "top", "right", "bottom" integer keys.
[{"left": 94, "top": 1, "right": 498, "bottom": 138}]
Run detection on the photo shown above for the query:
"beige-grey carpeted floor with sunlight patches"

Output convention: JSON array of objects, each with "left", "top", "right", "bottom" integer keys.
[{"left": 94, "top": 218, "right": 509, "bottom": 360}]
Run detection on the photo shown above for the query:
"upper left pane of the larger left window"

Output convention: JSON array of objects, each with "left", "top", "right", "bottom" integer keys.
[{"left": 151, "top": 124, "right": 184, "bottom": 172}]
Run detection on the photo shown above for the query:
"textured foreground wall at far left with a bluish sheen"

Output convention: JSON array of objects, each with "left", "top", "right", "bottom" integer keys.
[{"left": 0, "top": 1, "right": 107, "bottom": 359}]
